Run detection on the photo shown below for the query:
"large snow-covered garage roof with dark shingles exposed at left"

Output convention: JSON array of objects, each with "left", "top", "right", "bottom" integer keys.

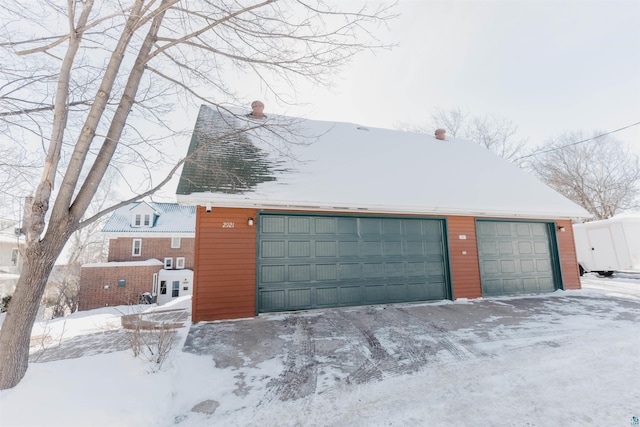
[{"left": 177, "top": 105, "right": 591, "bottom": 219}]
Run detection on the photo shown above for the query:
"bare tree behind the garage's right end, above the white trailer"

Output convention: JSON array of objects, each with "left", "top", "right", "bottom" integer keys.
[{"left": 529, "top": 132, "right": 640, "bottom": 219}]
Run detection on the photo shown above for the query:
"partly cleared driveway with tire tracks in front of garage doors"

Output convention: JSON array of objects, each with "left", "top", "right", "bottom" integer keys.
[{"left": 183, "top": 291, "right": 640, "bottom": 415}]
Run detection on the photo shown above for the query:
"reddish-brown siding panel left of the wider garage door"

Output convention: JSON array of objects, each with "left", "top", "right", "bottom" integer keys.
[{"left": 192, "top": 206, "right": 257, "bottom": 322}]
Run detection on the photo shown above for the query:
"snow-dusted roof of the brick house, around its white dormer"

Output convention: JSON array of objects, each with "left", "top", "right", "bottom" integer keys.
[{"left": 102, "top": 202, "right": 196, "bottom": 234}]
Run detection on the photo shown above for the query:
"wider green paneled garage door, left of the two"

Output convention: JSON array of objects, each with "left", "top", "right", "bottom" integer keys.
[{"left": 258, "top": 214, "right": 450, "bottom": 312}]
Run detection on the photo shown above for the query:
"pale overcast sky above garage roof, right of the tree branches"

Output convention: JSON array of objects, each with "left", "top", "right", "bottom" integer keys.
[{"left": 238, "top": 0, "right": 640, "bottom": 147}]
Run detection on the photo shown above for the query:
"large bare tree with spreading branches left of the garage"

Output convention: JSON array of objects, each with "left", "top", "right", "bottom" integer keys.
[{"left": 0, "top": 0, "right": 392, "bottom": 389}]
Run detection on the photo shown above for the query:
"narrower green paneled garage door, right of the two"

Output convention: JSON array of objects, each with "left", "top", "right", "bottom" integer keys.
[{"left": 476, "top": 220, "right": 556, "bottom": 296}]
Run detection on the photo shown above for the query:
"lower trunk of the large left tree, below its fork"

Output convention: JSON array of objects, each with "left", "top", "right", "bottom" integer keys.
[{"left": 0, "top": 241, "right": 63, "bottom": 390}]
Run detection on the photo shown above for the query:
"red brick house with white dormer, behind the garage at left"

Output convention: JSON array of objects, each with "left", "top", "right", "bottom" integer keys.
[{"left": 78, "top": 202, "right": 195, "bottom": 310}]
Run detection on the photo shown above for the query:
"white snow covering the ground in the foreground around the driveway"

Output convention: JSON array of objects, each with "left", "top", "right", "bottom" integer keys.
[{"left": 0, "top": 275, "right": 640, "bottom": 427}]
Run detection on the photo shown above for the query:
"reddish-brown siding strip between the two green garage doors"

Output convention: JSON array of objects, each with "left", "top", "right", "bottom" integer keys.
[{"left": 447, "top": 216, "right": 482, "bottom": 299}]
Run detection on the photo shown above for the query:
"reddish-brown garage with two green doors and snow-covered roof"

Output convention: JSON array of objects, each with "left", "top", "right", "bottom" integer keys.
[{"left": 177, "top": 106, "right": 589, "bottom": 321}]
